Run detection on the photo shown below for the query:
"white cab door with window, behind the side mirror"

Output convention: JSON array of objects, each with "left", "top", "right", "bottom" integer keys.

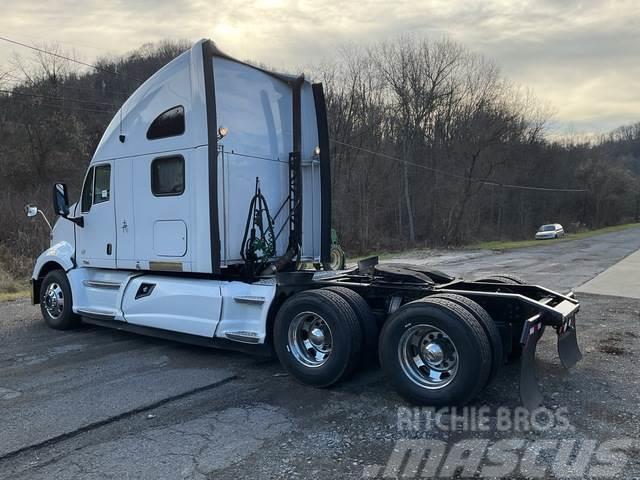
[{"left": 76, "top": 162, "right": 116, "bottom": 268}]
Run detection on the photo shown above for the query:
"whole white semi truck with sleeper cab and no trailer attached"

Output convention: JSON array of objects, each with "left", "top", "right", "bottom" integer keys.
[{"left": 29, "top": 40, "right": 580, "bottom": 408}]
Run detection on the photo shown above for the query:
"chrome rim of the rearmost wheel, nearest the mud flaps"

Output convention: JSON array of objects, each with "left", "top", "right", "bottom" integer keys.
[{"left": 398, "top": 325, "right": 459, "bottom": 390}]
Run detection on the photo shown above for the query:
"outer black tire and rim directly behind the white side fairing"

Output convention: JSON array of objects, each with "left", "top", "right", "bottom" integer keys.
[{"left": 273, "top": 290, "right": 362, "bottom": 387}]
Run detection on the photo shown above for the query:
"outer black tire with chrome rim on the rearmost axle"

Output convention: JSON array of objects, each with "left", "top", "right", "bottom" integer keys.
[{"left": 379, "top": 297, "right": 492, "bottom": 406}]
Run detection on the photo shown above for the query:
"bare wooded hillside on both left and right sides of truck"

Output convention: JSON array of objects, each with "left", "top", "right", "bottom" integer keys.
[{"left": 0, "top": 38, "right": 640, "bottom": 275}]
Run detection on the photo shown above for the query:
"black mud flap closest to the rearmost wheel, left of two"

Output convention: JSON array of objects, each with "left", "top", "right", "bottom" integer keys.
[{"left": 520, "top": 315, "right": 544, "bottom": 411}]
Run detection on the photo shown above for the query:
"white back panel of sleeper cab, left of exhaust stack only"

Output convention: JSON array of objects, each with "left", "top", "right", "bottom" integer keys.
[{"left": 213, "top": 57, "right": 293, "bottom": 266}]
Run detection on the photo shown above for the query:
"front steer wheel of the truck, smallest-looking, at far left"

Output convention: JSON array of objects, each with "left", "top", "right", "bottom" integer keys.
[{"left": 40, "top": 270, "right": 80, "bottom": 330}]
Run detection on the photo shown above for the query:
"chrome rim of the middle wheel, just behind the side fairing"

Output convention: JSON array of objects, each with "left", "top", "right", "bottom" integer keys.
[{"left": 288, "top": 312, "right": 333, "bottom": 368}]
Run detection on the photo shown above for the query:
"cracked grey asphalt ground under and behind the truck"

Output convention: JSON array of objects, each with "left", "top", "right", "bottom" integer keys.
[{"left": 0, "top": 229, "right": 640, "bottom": 480}]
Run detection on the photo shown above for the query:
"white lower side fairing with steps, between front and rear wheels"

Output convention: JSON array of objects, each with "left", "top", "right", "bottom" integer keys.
[{"left": 68, "top": 268, "right": 276, "bottom": 343}]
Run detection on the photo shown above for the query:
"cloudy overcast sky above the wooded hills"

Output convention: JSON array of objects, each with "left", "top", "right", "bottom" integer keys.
[{"left": 0, "top": 0, "right": 640, "bottom": 134}]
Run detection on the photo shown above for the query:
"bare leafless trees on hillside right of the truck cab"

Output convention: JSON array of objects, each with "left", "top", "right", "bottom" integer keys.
[{"left": 320, "top": 39, "right": 640, "bottom": 251}]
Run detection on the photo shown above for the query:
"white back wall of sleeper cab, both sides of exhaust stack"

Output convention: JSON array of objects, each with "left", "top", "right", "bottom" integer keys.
[{"left": 206, "top": 39, "right": 321, "bottom": 267}]
